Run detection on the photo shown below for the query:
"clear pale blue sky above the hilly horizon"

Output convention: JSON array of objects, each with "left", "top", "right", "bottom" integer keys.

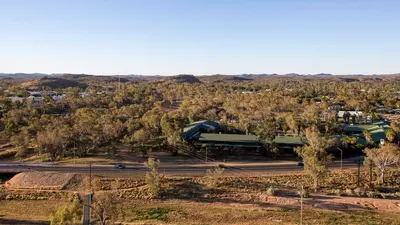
[{"left": 0, "top": 0, "right": 400, "bottom": 75}]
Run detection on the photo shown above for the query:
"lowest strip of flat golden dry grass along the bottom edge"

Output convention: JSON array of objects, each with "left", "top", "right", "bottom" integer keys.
[{"left": 0, "top": 200, "right": 400, "bottom": 225}]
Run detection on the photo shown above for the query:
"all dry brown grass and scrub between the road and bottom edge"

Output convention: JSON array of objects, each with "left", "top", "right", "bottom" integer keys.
[{"left": 0, "top": 170, "right": 400, "bottom": 224}]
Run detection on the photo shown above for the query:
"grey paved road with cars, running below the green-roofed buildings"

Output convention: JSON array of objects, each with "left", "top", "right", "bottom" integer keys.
[{"left": 0, "top": 162, "right": 357, "bottom": 175}]
